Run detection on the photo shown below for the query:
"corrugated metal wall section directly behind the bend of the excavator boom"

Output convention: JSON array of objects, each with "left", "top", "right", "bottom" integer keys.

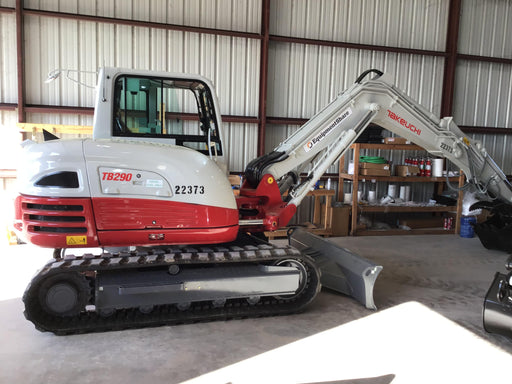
[{"left": 267, "top": 42, "right": 444, "bottom": 118}]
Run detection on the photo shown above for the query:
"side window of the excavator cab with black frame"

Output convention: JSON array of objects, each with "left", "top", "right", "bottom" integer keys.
[{"left": 112, "top": 76, "right": 222, "bottom": 155}]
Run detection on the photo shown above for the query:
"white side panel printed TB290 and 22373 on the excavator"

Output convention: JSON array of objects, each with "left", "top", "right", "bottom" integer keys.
[{"left": 84, "top": 139, "right": 237, "bottom": 209}]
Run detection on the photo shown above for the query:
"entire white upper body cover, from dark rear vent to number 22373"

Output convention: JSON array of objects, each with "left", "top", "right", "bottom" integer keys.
[{"left": 18, "top": 139, "right": 237, "bottom": 209}]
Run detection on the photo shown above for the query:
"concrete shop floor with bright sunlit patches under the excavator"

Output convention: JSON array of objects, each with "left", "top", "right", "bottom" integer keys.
[{"left": 0, "top": 235, "right": 512, "bottom": 384}]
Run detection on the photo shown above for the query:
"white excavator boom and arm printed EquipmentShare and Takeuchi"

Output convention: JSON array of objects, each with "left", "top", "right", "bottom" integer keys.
[{"left": 245, "top": 70, "right": 512, "bottom": 229}]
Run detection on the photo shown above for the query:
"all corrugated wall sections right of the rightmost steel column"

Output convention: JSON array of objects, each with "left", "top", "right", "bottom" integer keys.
[{"left": 453, "top": 0, "right": 512, "bottom": 174}]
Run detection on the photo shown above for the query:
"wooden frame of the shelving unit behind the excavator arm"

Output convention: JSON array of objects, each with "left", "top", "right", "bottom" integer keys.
[{"left": 338, "top": 143, "right": 464, "bottom": 236}]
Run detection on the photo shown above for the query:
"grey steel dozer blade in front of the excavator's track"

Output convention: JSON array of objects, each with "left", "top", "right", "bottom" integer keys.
[{"left": 288, "top": 228, "right": 382, "bottom": 309}]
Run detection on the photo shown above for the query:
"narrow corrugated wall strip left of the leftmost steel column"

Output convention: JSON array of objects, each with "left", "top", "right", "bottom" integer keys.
[{"left": 0, "top": 13, "right": 18, "bottom": 103}]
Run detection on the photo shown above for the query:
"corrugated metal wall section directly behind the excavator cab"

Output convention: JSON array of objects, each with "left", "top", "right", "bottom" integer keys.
[{"left": 25, "top": 16, "right": 260, "bottom": 116}]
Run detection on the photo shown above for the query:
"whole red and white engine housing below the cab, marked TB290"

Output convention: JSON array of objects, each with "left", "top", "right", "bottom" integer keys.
[{"left": 16, "top": 139, "right": 239, "bottom": 248}]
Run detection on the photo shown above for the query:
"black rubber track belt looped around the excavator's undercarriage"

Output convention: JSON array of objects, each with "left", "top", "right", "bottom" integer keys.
[{"left": 23, "top": 243, "right": 320, "bottom": 335}]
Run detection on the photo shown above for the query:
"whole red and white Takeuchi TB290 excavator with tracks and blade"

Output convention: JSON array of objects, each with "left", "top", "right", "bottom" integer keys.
[{"left": 15, "top": 68, "right": 512, "bottom": 334}]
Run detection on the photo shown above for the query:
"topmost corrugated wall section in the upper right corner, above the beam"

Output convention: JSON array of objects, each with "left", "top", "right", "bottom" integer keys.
[{"left": 459, "top": 0, "right": 512, "bottom": 59}]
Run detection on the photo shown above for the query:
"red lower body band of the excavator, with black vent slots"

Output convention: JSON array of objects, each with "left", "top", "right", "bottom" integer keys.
[{"left": 16, "top": 196, "right": 238, "bottom": 248}]
